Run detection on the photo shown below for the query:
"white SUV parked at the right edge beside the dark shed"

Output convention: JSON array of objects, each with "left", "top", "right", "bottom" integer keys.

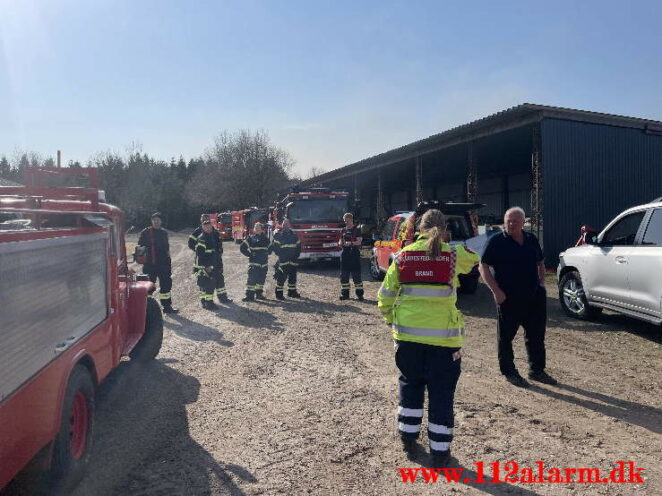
[{"left": 557, "top": 198, "right": 662, "bottom": 324}]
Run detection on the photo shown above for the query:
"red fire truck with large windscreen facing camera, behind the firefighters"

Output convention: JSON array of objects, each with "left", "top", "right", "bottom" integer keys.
[{"left": 273, "top": 188, "right": 349, "bottom": 260}]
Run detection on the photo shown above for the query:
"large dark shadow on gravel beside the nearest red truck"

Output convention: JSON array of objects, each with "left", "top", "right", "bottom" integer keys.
[{"left": 72, "top": 360, "right": 257, "bottom": 496}]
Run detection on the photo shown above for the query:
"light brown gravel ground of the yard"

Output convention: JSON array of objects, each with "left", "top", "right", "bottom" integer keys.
[{"left": 39, "top": 235, "right": 662, "bottom": 496}]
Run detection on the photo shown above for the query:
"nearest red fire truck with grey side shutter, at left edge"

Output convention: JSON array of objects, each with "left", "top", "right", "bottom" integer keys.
[{"left": 0, "top": 169, "right": 163, "bottom": 493}]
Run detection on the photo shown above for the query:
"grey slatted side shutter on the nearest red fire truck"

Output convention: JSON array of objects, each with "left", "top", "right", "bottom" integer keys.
[{"left": 0, "top": 233, "right": 108, "bottom": 401}]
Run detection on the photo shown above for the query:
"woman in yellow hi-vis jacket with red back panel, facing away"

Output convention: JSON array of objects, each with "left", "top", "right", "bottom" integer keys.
[{"left": 378, "top": 209, "right": 480, "bottom": 467}]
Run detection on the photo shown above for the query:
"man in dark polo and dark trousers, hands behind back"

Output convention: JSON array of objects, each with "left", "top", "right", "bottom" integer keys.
[{"left": 479, "top": 207, "right": 557, "bottom": 388}]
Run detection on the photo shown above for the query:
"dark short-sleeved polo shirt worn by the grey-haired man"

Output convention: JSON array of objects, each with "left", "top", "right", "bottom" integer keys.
[{"left": 481, "top": 231, "right": 544, "bottom": 300}]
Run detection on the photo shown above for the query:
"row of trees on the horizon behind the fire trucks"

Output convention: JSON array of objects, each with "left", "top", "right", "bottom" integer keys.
[{"left": 0, "top": 131, "right": 301, "bottom": 229}]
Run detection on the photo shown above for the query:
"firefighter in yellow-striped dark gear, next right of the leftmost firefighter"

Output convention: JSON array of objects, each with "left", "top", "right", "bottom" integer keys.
[{"left": 193, "top": 220, "right": 232, "bottom": 309}]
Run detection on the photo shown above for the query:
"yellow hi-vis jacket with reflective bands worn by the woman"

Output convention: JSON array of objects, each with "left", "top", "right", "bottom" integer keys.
[{"left": 378, "top": 235, "right": 480, "bottom": 348}]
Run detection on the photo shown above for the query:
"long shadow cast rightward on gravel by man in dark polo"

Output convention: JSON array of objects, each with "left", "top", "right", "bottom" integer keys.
[{"left": 531, "top": 383, "right": 662, "bottom": 434}]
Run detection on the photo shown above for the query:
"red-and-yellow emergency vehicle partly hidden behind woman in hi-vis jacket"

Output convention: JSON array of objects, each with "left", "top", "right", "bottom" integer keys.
[{"left": 370, "top": 201, "right": 483, "bottom": 294}]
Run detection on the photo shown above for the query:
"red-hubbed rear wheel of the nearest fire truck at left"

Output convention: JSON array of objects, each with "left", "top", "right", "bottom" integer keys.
[{"left": 51, "top": 365, "right": 95, "bottom": 494}]
